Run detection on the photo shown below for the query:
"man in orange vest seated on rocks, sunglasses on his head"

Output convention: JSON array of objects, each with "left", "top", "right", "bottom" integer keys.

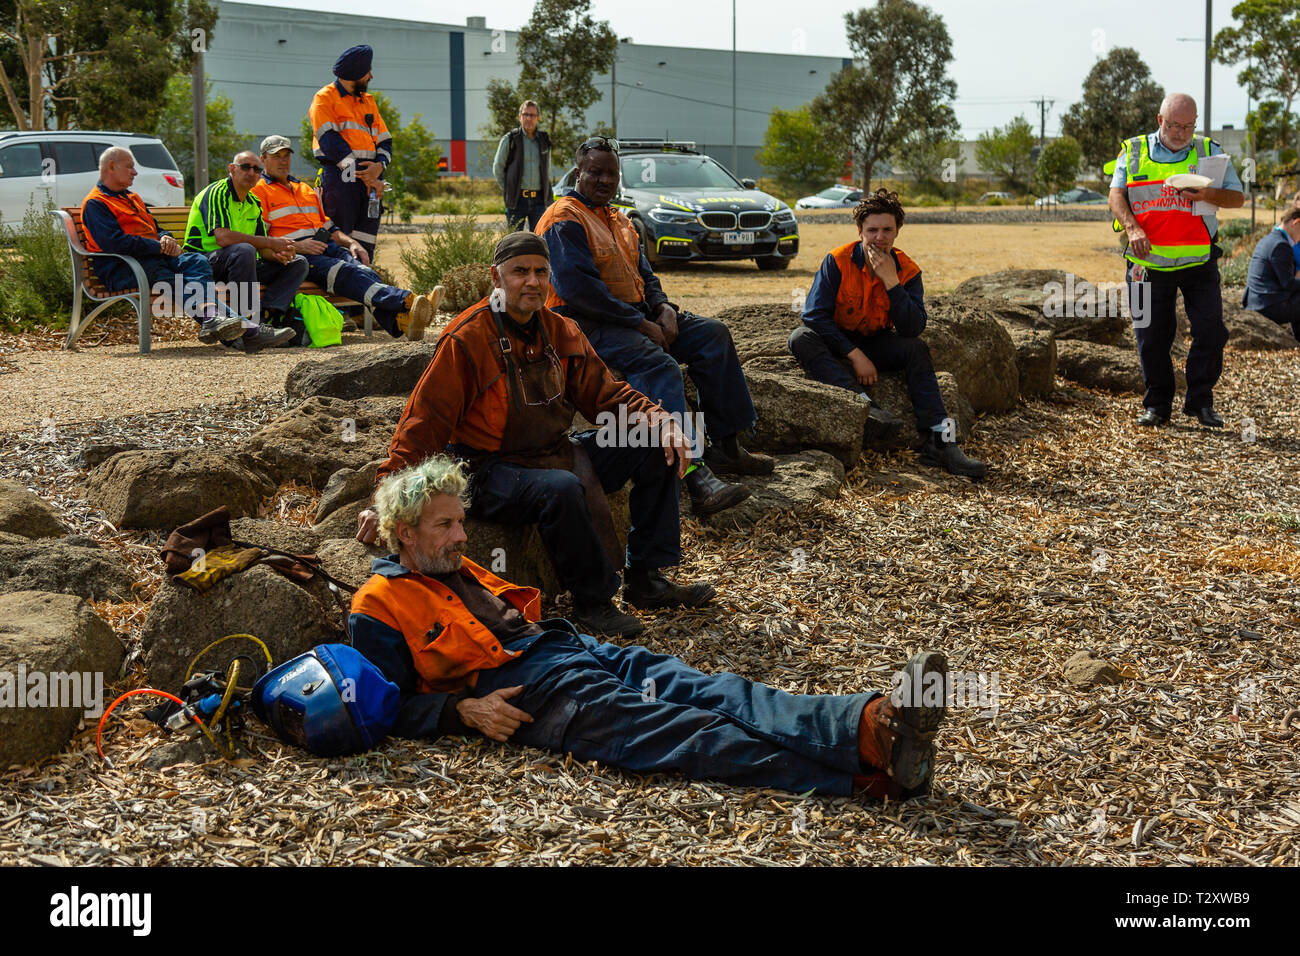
[{"left": 537, "top": 137, "right": 775, "bottom": 516}]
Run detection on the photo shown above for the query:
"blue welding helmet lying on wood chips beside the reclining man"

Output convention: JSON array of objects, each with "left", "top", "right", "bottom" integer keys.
[{"left": 252, "top": 644, "right": 399, "bottom": 757}]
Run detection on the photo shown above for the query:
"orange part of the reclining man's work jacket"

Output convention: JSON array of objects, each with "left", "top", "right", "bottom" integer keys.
[{"left": 352, "top": 558, "right": 542, "bottom": 693}]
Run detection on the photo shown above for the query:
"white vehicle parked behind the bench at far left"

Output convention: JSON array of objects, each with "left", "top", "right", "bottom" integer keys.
[{"left": 0, "top": 130, "right": 185, "bottom": 228}]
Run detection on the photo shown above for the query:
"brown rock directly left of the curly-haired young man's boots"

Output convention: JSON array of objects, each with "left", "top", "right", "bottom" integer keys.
[{"left": 745, "top": 369, "right": 867, "bottom": 468}]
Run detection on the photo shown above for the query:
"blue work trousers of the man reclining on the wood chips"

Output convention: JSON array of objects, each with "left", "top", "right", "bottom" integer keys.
[{"left": 473, "top": 631, "right": 876, "bottom": 796}]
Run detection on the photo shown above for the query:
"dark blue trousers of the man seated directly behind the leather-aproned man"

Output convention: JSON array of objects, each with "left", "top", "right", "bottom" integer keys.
[{"left": 579, "top": 312, "right": 758, "bottom": 441}]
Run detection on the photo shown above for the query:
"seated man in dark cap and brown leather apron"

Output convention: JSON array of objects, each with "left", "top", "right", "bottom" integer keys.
[{"left": 356, "top": 232, "right": 714, "bottom": 635}]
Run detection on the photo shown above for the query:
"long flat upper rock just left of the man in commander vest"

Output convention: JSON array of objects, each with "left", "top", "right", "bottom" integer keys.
[{"left": 953, "top": 269, "right": 1130, "bottom": 345}]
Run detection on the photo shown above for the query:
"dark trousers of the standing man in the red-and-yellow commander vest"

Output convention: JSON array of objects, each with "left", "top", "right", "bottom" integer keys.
[{"left": 1125, "top": 259, "right": 1227, "bottom": 415}]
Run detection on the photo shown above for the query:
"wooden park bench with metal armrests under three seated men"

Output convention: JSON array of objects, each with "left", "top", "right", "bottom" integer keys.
[{"left": 52, "top": 206, "right": 374, "bottom": 355}]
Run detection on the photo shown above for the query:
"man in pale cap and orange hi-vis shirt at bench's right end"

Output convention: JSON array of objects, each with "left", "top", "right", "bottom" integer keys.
[{"left": 252, "top": 135, "right": 442, "bottom": 342}]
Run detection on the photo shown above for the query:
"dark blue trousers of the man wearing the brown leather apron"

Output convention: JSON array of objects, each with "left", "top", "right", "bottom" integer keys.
[{"left": 472, "top": 432, "right": 681, "bottom": 605}]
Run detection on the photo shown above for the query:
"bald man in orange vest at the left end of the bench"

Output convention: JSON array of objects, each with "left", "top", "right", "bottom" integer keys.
[{"left": 82, "top": 146, "right": 243, "bottom": 345}]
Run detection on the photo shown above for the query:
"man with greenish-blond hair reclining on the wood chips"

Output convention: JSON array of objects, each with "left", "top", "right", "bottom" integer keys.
[{"left": 348, "top": 452, "right": 948, "bottom": 799}]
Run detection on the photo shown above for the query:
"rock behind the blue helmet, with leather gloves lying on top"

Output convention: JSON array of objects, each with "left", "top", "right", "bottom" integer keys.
[{"left": 140, "top": 564, "right": 343, "bottom": 693}]
